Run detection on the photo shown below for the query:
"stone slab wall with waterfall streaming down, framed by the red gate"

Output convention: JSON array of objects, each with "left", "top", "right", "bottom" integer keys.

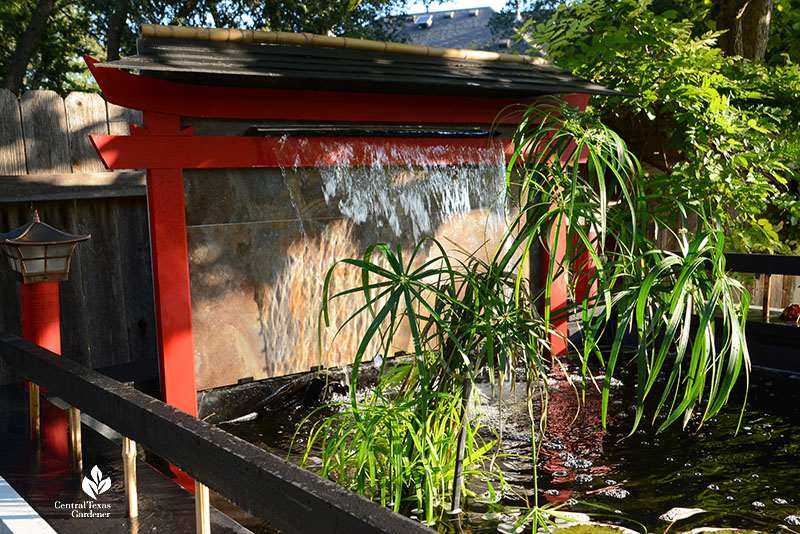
[{"left": 185, "top": 138, "right": 506, "bottom": 388}]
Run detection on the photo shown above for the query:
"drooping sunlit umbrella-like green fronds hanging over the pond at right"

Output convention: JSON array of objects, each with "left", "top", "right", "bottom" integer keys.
[{"left": 509, "top": 101, "right": 752, "bottom": 436}]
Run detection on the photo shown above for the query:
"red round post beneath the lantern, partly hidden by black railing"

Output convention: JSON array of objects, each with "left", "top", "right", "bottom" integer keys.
[{"left": 19, "top": 282, "right": 69, "bottom": 461}]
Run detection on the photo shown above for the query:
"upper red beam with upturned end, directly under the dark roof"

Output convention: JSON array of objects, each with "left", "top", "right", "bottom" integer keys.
[{"left": 84, "top": 55, "right": 534, "bottom": 124}]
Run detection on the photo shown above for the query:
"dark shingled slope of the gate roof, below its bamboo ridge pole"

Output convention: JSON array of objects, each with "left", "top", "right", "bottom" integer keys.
[{"left": 100, "top": 37, "right": 620, "bottom": 98}]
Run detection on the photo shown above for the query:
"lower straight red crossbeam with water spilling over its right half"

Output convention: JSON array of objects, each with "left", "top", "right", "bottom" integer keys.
[{"left": 90, "top": 135, "right": 510, "bottom": 169}]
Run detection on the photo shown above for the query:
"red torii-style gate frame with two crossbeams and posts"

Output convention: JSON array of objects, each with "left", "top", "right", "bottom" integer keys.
[{"left": 85, "top": 37, "right": 589, "bottom": 415}]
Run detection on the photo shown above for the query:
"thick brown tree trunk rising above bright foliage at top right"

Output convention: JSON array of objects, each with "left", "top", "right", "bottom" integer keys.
[{"left": 714, "top": 0, "right": 774, "bottom": 61}]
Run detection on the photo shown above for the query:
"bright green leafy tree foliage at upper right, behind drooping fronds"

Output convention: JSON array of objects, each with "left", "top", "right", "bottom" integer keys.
[{"left": 534, "top": 0, "right": 800, "bottom": 252}]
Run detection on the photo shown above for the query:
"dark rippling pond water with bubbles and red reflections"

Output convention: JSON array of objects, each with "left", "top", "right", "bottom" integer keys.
[{"left": 216, "top": 362, "right": 800, "bottom": 533}]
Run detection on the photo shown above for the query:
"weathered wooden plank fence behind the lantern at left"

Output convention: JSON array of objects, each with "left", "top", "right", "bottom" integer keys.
[{"left": 0, "top": 89, "right": 156, "bottom": 384}]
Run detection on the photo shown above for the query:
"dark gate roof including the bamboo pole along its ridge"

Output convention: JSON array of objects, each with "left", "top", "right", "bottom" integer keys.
[{"left": 98, "top": 25, "right": 623, "bottom": 100}]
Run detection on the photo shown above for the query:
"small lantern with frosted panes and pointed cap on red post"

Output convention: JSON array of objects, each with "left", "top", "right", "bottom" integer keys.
[{"left": 0, "top": 212, "right": 91, "bottom": 284}]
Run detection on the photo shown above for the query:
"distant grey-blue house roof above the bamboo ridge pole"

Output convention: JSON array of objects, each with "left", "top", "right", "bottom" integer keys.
[{"left": 403, "top": 7, "right": 531, "bottom": 54}]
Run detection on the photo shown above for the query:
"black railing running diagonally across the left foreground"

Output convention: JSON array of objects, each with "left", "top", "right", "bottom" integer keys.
[{"left": 0, "top": 332, "right": 432, "bottom": 534}]
